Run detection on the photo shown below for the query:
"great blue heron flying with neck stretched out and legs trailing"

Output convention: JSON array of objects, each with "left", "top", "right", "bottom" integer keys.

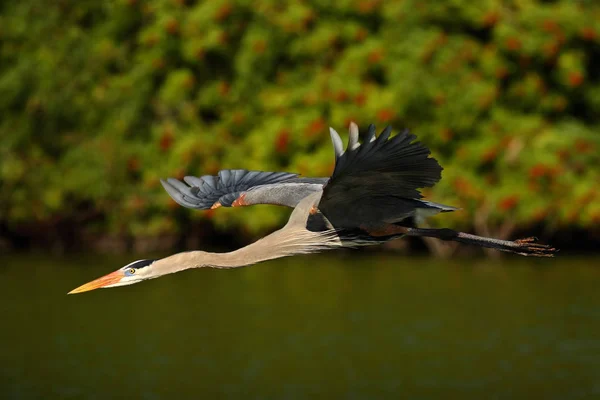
[{"left": 70, "top": 123, "right": 556, "bottom": 293}]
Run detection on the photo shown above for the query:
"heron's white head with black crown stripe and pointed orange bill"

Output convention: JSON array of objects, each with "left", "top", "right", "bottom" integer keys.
[{"left": 69, "top": 260, "right": 157, "bottom": 294}]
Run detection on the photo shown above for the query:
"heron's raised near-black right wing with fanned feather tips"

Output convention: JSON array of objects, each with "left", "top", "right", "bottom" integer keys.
[{"left": 318, "top": 124, "right": 442, "bottom": 228}]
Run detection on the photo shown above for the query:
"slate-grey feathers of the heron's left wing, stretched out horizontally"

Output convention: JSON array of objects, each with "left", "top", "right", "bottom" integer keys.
[{"left": 160, "top": 169, "right": 300, "bottom": 210}]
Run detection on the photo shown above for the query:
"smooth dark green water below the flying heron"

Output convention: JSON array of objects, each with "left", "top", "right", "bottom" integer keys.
[{"left": 0, "top": 252, "right": 600, "bottom": 399}]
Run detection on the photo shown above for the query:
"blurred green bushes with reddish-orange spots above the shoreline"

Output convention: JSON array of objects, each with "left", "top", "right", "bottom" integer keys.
[{"left": 0, "top": 0, "right": 600, "bottom": 241}]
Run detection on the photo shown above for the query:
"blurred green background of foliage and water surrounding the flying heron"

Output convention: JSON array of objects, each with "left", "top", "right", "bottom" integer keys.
[{"left": 0, "top": 0, "right": 600, "bottom": 400}]
